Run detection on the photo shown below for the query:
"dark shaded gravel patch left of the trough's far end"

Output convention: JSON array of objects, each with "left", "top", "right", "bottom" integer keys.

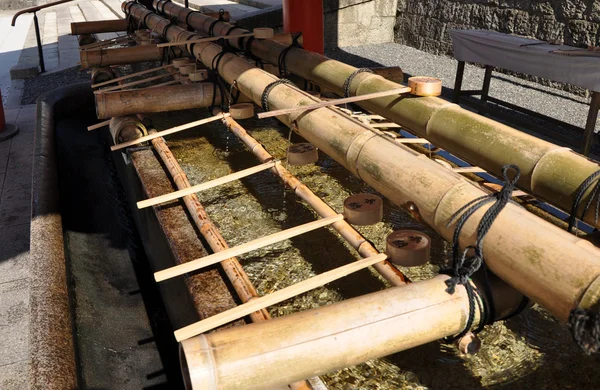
[{"left": 21, "top": 66, "right": 90, "bottom": 105}]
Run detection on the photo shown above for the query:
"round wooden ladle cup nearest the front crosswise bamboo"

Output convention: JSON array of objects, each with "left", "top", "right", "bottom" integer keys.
[{"left": 385, "top": 230, "right": 431, "bottom": 267}]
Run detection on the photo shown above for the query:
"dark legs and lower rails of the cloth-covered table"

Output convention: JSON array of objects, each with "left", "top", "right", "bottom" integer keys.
[{"left": 452, "top": 61, "right": 600, "bottom": 156}]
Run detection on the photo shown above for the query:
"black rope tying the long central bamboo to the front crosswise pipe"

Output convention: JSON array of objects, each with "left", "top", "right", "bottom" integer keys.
[{"left": 445, "top": 164, "right": 521, "bottom": 338}]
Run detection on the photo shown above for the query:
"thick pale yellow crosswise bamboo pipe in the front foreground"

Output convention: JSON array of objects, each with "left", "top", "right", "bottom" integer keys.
[{"left": 180, "top": 275, "right": 478, "bottom": 390}]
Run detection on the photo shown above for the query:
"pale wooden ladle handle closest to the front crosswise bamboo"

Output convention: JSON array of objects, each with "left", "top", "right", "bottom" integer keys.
[{"left": 175, "top": 254, "right": 387, "bottom": 342}]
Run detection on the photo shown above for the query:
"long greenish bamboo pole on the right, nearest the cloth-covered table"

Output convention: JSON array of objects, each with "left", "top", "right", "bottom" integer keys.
[{"left": 154, "top": 0, "right": 600, "bottom": 232}]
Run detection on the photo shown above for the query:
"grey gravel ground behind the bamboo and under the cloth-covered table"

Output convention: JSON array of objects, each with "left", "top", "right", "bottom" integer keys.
[{"left": 326, "top": 43, "right": 600, "bottom": 155}]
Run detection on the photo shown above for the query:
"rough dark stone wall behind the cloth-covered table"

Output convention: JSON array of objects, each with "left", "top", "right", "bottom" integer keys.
[{"left": 395, "top": 0, "right": 600, "bottom": 54}]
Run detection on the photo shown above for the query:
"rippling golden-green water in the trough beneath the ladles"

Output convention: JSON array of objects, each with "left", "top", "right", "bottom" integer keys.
[{"left": 149, "top": 111, "right": 600, "bottom": 389}]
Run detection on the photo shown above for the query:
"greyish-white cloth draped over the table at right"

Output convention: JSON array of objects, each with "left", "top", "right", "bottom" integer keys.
[{"left": 450, "top": 30, "right": 600, "bottom": 91}]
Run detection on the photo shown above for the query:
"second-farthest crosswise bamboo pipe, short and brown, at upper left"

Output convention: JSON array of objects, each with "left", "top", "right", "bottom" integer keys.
[{"left": 79, "top": 45, "right": 163, "bottom": 69}]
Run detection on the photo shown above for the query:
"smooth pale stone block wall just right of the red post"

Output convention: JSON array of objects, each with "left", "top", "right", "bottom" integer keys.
[{"left": 323, "top": 0, "right": 402, "bottom": 48}]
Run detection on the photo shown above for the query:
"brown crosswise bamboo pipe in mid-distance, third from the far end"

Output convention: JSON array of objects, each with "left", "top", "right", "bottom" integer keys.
[{"left": 95, "top": 83, "right": 221, "bottom": 119}]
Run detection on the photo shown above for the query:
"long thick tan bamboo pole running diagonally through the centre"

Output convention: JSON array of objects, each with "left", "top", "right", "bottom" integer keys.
[{"left": 123, "top": 4, "right": 600, "bottom": 320}]
